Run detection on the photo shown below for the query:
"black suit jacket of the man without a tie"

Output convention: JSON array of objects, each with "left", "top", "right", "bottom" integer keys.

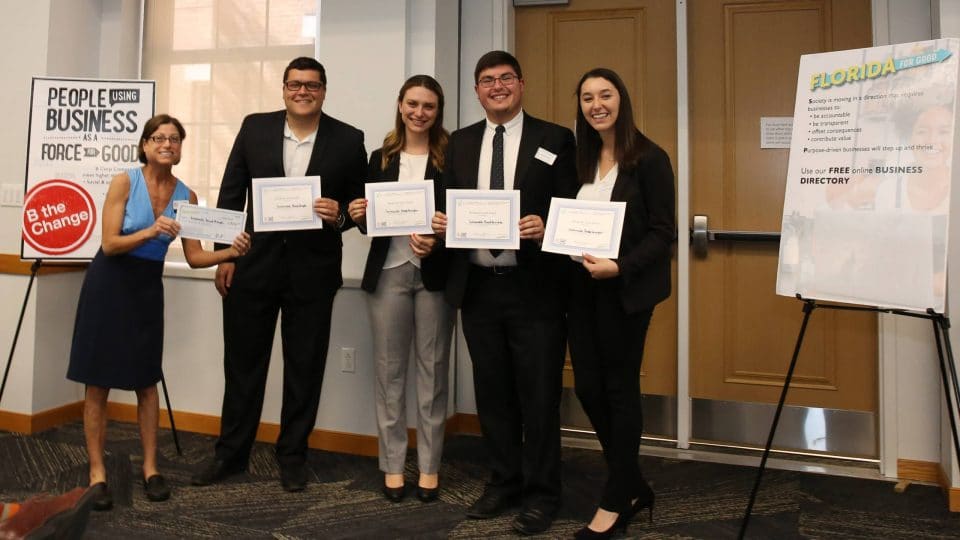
[{"left": 217, "top": 110, "right": 367, "bottom": 295}]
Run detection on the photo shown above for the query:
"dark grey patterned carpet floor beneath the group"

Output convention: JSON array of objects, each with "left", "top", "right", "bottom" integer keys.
[{"left": 0, "top": 423, "right": 960, "bottom": 539}]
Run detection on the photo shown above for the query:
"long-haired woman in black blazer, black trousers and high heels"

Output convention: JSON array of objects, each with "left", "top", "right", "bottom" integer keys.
[{"left": 567, "top": 68, "right": 676, "bottom": 538}]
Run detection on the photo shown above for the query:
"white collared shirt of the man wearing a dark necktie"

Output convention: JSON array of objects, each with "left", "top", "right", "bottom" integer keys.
[{"left": 470, "top": 110, "right": 523, "bottom": 266}]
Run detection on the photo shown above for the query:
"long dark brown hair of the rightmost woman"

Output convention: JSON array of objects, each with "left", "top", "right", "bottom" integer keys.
[{"left": 577, "top": 68, "right": 652, "bottom": 184}]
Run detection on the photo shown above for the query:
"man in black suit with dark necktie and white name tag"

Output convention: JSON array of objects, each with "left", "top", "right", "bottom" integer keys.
[{"left": 433, "top": 51, "right": 577, "bottom": 534}]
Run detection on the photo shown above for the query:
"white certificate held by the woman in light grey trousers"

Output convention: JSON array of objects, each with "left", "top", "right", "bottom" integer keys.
[{"left": 364, "top": 180, "right": 435, "bottom": 236}]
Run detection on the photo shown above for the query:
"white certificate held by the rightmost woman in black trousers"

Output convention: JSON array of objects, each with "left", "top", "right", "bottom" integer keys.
[{"left": 541, "top": 197, "right": 627, "bottom": 259}]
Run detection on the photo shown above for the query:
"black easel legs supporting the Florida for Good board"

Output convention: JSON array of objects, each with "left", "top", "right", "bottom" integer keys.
[{"left": 738, "top": 294, "right": 960, "bottom": 540}]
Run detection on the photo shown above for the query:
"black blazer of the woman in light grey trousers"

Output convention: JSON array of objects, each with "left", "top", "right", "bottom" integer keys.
[{"left": 360, "top": 148, "right": 447, "bottom": 293}]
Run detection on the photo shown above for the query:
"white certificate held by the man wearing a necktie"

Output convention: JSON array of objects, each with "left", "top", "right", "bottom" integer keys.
[{"left": 446, "top": 189, "right": 520, "bottom": 249}]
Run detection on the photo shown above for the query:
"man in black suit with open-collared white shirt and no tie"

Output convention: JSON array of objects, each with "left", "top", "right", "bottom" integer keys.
[{"left": 192, "top": 57, "right": 366, "bottom": 491}]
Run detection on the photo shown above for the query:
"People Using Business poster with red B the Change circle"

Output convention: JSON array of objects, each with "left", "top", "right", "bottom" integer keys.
[{"left": 20, "top": 77, "right": 155, "bottom": 259}]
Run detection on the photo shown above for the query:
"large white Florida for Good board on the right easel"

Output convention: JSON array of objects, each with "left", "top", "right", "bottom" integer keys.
[{"left": 777, "top": 39, "right": 960, "bottom": 313}]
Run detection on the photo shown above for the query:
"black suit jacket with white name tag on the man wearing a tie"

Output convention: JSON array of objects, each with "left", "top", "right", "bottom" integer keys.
[{"left": 443, "top": 113, "right": 577, "bottom": 310}]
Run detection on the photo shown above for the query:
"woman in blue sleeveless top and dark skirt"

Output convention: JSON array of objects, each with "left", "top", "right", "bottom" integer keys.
[{"left": 67, "top": 114, "right": 250, "bottom": 510}]
